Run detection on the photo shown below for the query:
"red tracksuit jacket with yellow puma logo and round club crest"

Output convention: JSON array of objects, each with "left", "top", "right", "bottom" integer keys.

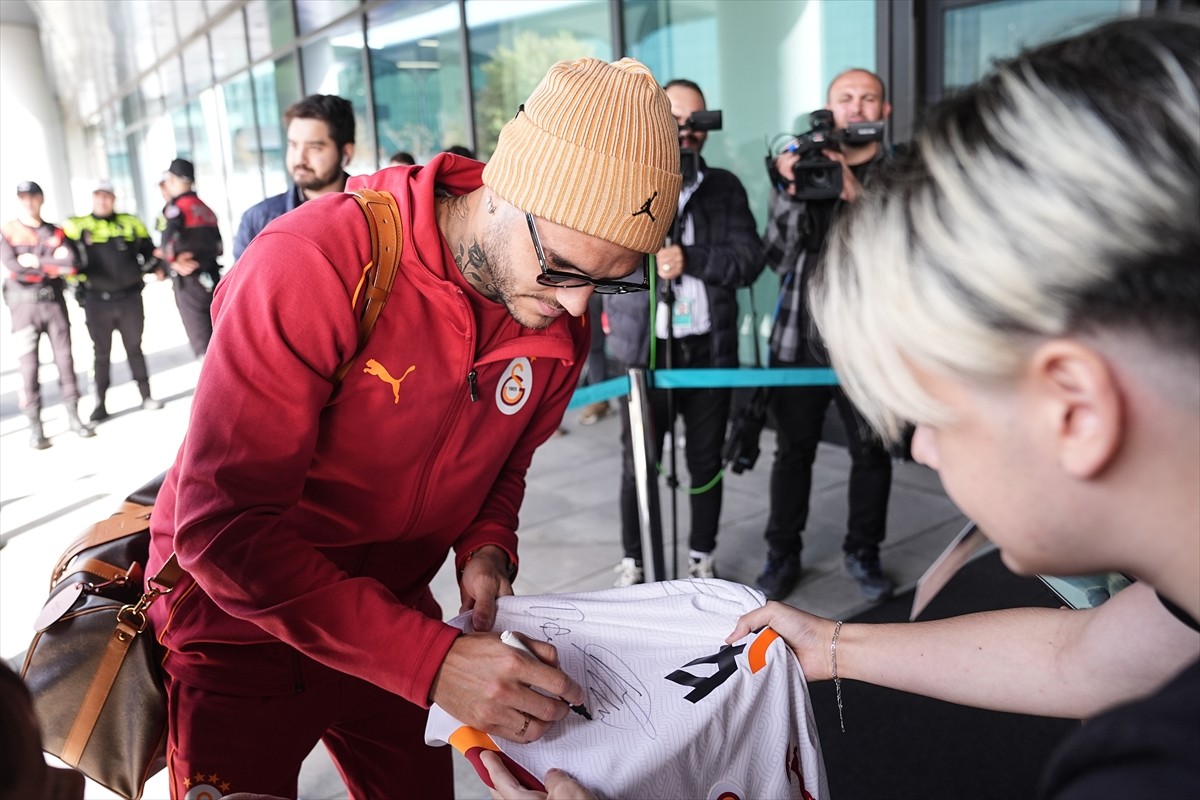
[{"left": 146, "top": 157, "right": 588, "bottom": 705}]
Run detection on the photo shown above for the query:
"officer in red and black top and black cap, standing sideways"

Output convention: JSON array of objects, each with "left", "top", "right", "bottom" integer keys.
[{"left": 161, "top": 158, "right": 223, "bottom": 359}]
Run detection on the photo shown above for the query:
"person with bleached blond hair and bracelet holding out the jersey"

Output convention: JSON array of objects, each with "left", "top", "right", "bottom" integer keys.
[{"left": 481, "top": 17, "right": 1200, "bottom": 800}]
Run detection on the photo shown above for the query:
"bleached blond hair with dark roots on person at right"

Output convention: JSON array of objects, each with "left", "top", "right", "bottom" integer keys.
[{"left": 810, "top": 18, "right": 1200, "bottom": 439}]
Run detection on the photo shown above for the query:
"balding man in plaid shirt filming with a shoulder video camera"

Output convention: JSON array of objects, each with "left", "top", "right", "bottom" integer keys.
[{"left": 757, "top": 70, "right": 894, "bottom": 601}]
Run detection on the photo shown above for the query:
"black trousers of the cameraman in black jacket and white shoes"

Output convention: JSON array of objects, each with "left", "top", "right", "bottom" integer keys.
[{"left": 620, "top": 336, "right": 733, "bottom": 560}]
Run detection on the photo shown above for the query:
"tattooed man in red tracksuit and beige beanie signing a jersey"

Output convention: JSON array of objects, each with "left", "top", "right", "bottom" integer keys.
[{"left": 146, "top": 59, "right": 680, "bottom": 799}]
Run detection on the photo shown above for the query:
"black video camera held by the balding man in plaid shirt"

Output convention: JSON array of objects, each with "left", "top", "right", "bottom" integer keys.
[{"left": 767, "top": 108, "right": 883, "bottom": 200}]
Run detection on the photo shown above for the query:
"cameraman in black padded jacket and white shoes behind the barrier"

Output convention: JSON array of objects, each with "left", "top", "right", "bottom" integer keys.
[{"left": 604, "top": 80, "right": 763, "bottom": 587}]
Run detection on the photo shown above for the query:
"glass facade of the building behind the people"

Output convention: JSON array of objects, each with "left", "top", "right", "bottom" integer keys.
[{"left": 44, "top": 0, "right": 1139, "bottom": 363}]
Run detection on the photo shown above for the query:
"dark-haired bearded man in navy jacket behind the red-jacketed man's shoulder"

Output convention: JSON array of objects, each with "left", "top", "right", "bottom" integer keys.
[{"left": 233, "top": 95, "right": 354, "bottom": 260}]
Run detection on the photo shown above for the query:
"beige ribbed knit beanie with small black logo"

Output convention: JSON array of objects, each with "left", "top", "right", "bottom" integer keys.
[{"left": 484, "top": 59, "right": 683, "bottom": 253}]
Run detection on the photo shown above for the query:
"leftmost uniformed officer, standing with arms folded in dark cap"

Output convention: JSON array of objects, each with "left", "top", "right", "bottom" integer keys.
[{"left": 0, "top": 181, "right": 95, "bottom": 450}]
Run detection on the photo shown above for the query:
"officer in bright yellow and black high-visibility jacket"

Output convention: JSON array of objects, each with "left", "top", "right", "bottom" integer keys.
[{"left": 62, "top": 180, "right": 162, "bottom": 422}]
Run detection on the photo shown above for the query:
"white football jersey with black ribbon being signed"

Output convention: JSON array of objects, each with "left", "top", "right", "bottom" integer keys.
[{"left": 425, "top": 579, "right": 829, "bottom": 800}]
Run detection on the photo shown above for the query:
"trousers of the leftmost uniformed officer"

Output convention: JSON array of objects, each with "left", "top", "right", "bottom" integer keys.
[{"left": 10, "top": 297, "right": 79, "bottom": 416}]
